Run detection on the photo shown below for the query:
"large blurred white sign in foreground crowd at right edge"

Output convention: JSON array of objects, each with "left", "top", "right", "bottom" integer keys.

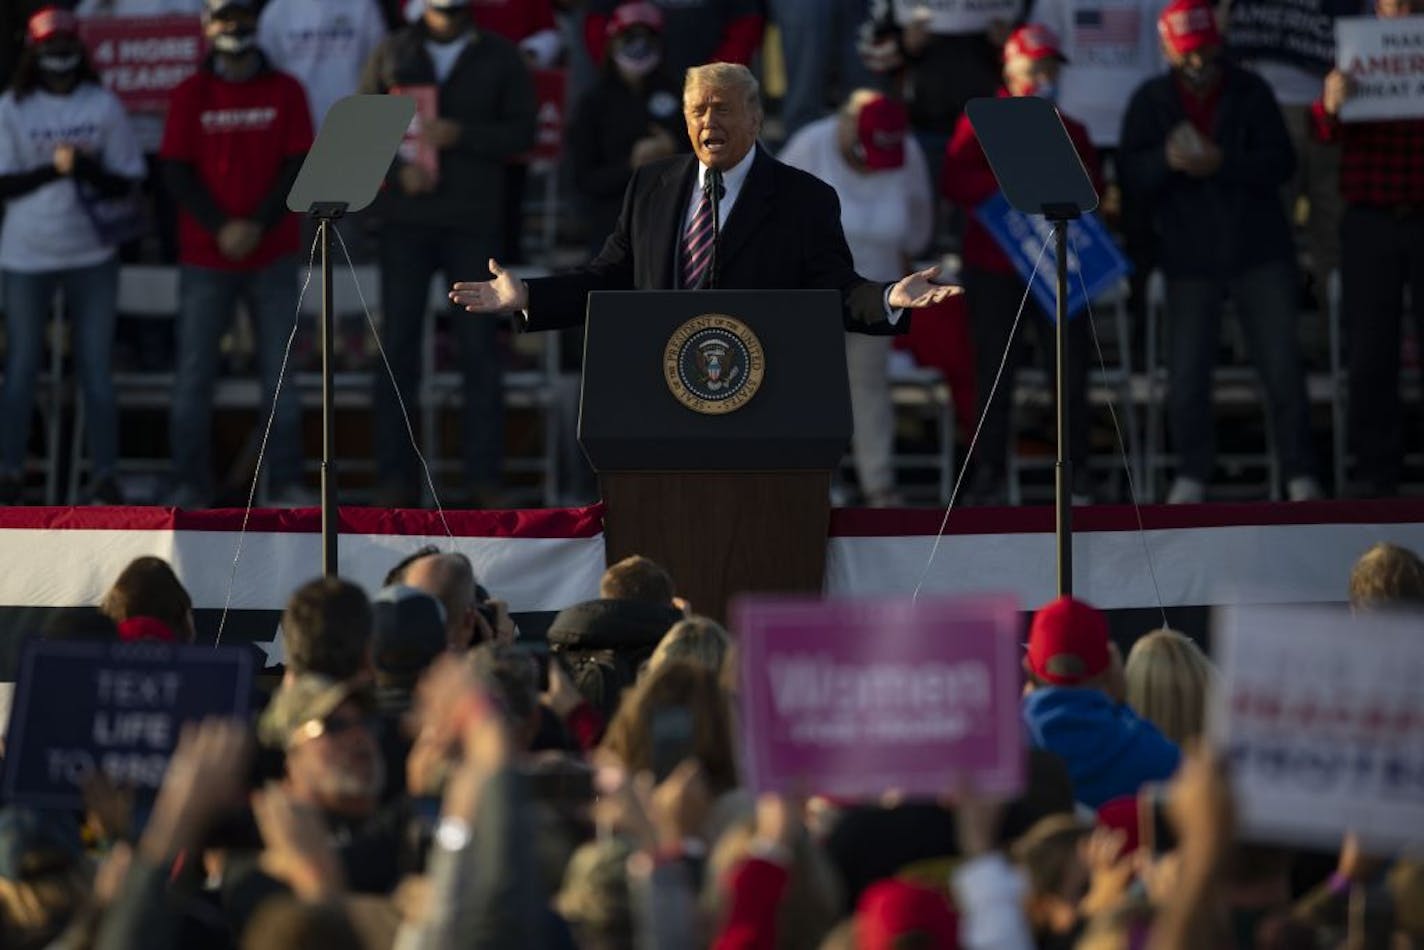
[{"left": 1210, "top": 607, "right": 1424, "bottom": 853}]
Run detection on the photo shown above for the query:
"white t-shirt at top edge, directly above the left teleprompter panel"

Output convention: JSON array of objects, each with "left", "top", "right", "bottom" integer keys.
[{"left": 258, "top": 0, "right": 386, "bottom": 128}]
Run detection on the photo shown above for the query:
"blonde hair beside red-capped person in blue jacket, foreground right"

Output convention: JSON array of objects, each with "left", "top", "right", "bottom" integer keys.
[{"left": 1124, "top": 630, "right": 1216, "bottom": 745}]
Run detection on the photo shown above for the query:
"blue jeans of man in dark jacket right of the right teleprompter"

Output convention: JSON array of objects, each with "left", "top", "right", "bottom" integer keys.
[{"left": 1166, "top": 261, "right": 1316, "bottom": 481}]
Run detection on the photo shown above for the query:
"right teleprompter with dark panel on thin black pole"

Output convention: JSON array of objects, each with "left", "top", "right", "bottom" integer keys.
[{"left": 965, "top": 95, "right": 1098, "bottom": 594}]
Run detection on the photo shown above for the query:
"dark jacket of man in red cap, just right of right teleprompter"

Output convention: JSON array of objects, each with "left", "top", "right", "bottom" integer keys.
[{"left": 1118, "top": 63, "right": 1296, "bottom": 278}]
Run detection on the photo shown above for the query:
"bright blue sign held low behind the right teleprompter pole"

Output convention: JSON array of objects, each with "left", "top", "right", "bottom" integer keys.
[{"left": 974, "top": 192, "right": 1132, "bottom": 319}]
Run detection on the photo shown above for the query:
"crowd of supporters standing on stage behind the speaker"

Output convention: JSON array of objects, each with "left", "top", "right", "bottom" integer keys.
[{"left": 0, "top": 0, "right": 1424, "bottom": 507}]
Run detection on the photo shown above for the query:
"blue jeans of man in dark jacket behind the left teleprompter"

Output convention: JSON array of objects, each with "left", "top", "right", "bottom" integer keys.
[{"left": 372, "top": 222, "right": 504, "bottom": 494}]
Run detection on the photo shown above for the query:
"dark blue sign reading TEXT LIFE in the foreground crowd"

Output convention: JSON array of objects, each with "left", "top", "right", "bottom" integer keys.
[{"left": 4, "top": 641, "right": 252, "bottom": 808}]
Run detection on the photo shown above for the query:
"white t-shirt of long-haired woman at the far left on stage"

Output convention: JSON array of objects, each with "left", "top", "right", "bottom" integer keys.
[{"left": 0, "top": 83, "right": 145, "bottom": 272}]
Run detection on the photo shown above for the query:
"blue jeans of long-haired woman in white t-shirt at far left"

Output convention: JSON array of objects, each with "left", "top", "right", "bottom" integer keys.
[{"left": 0, "top": 258, "right": 118, "bottom": 480}]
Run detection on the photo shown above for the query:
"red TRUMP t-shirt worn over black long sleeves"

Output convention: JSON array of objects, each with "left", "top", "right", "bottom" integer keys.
[{"left": 158, "top": 68, "right": 312, "bottom": 271}]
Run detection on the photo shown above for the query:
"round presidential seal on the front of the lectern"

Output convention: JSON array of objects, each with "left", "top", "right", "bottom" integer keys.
[{"left": 662, "top": 313, "right": 766, "bottom": 416}]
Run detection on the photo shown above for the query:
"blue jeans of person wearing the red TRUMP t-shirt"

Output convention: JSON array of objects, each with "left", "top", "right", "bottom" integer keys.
[{"left": 168, "top": 256, "right": 302, "bottom": 499}]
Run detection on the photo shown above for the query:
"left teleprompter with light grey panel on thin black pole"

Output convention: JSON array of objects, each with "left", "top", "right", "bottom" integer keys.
[{"left": 286, "top": 95, "right": 416, "bottom": 577}]
